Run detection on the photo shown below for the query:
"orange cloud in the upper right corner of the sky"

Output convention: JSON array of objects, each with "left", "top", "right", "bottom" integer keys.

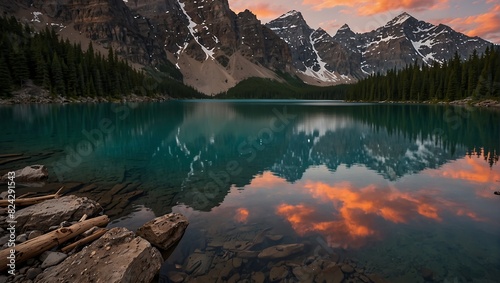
[{"left": 433, "top": 2, "right": 500, "bottom": 44}]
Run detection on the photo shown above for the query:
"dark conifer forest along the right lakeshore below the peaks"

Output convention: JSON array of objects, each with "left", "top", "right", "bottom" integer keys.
[{"left": 347, "top": 46, "right": 500, "bottom": 101}]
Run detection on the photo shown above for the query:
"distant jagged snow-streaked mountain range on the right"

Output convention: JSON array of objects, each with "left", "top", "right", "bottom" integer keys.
[{"left": 267, "top": 11, "right": 491, "bottom": 82}]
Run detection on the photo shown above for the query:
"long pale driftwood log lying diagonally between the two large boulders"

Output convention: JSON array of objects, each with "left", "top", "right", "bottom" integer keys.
[{"left": 0, "top": 215, "right": 109, "bottom": 271}]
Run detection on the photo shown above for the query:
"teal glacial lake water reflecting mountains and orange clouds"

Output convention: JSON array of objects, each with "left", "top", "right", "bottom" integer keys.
[{"left": 0, "top": 100, "right": 500, "bottom": 282}]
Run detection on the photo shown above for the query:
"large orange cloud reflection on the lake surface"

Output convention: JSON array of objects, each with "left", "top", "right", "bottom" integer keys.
[{"left": 276, "top": 182, "right": 484, "bottom": 248}]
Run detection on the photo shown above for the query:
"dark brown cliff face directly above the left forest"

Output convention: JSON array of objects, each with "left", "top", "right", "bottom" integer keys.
[{"left": 32, "top": 0, "right": 166, "bottom": 65}]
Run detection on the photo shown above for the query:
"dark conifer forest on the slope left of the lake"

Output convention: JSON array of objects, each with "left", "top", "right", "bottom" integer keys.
[{"left": 0, "top": 17, "right": 201, "bottom": 97}]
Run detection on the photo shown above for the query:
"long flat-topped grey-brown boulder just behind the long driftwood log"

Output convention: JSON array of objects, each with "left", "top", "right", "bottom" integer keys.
[{"left": 16, "top": 195, "right": 102, "bottom": 233}]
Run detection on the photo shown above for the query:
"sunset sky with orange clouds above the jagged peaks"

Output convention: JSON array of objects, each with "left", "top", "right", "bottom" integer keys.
[{"left": 229, "top": 0, "right": 500, "bottom": 44}]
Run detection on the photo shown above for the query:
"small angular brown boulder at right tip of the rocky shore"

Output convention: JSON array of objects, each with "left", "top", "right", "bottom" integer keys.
[{"left": 137, "top": 213, "right": 189, "bottom": 250}]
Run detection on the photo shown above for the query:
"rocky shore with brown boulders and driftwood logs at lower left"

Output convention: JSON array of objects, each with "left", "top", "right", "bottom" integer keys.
[{"left": 0, "top": 165, "right": 188, "bottom": 283}]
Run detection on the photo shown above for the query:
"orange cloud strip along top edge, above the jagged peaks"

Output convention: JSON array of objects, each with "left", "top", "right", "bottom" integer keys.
[{"left": 302, "top": 0, "right": 448, "bottom": 15}]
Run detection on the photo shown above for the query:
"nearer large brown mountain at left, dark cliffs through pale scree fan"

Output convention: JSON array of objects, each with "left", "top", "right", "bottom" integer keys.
[{"left": 0, "top": 0, "right": 293, "bottom": 94}]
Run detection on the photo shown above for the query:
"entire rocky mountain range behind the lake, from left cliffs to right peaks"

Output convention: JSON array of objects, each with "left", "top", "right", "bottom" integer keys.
[{"left": 0, "top": 0, "right": 490, "bottom": 94}]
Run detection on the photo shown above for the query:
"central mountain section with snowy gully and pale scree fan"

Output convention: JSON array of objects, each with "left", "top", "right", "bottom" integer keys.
[{"left": 126, "top": 0, "right": 291, "bottom": 94}]
